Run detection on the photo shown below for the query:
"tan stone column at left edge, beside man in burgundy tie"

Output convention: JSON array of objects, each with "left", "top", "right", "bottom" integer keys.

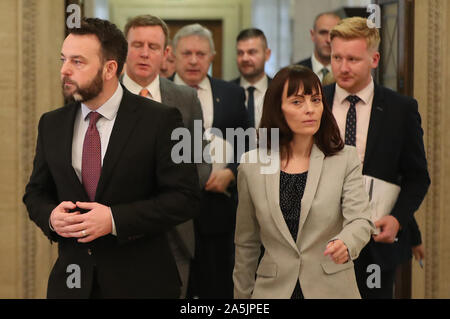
[{"left": 0, "top": 0, "right": 65, "bottom": 298}]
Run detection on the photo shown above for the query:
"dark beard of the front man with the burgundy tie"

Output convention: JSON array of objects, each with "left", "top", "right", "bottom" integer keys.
[{"left": 62, "top": 68, "right": 103, "bottom": 103}]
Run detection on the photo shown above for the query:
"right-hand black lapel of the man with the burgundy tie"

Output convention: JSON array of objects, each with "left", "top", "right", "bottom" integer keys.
[{"left": 95, "top": 86, "right": 139, "bottom": 200}]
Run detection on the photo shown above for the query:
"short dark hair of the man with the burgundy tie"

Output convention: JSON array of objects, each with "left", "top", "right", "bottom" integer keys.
[{"left": 69, "top": 18, "right": 128, "bottom": 77}]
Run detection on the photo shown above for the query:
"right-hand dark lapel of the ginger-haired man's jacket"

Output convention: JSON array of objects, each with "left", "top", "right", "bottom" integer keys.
[{"left": 364, "top": 85, "right": 387, "bottom": 169}]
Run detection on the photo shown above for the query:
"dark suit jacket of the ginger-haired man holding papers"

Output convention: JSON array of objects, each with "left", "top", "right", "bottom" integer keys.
[{"left": 324, "top": 84, "right": 430, "bottom": 269}]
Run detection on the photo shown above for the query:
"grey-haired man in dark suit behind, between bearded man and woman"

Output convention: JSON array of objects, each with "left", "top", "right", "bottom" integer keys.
[{"left": 173, "top": 24, "right": 248, "bottom": 298}]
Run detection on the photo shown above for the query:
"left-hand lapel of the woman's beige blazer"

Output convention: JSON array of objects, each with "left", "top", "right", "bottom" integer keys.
[{"left": 265, "top": 161, "right": 298, "bottom": 254}]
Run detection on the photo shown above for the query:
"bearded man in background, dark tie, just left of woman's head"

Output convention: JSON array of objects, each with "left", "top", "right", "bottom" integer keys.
[{"left": 232, "top": 28, "right": 271, "bottom": 128}]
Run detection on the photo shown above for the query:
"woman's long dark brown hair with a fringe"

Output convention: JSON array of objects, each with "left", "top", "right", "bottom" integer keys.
[{"left": 260, "top": 65, "right": 344, "bottom": 158}]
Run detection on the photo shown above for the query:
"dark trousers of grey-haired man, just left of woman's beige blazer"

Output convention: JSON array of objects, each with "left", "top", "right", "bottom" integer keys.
[{"left": 189, "top": 233, "right": 234, "bottom": 299}]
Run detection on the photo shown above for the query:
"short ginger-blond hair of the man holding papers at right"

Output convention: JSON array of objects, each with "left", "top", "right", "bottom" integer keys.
[{"left": 330, "top": 17, "right": 380, "bottom": 51}]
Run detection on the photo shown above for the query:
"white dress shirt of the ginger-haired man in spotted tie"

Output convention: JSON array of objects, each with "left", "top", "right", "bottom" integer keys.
[{"left": 333, "top": 79, "right": 374, "bottom": 163}]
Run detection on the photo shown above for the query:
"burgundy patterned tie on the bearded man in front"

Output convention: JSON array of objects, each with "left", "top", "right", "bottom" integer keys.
[{"left": 81, "top": 112, "right": 102, "bottom": 201}]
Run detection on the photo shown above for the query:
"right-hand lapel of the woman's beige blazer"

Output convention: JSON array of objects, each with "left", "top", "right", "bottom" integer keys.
[{"left": 297, "top": 144, "right": 325, "bottom": 243}]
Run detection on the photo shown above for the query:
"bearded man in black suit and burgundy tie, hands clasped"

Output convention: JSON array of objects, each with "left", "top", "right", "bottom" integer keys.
[{"left": 23, "top": 19, "right": 199, "bottom": 298}]
